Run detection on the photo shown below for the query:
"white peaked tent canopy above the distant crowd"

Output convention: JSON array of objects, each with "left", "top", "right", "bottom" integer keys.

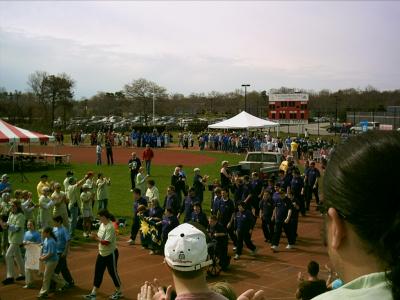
[{"left": 208, "top": 111, "right": 279, "bottom": 129}]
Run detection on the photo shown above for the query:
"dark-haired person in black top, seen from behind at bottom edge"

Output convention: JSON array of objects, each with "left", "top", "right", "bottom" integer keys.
[{"left": 296, "top": 261, "right": 327, "bottom": 300}]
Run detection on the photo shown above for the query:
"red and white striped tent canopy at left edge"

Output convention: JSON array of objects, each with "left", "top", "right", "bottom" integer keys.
[{"left": 0, "top": 119, "right": 54, "bottom": 144}]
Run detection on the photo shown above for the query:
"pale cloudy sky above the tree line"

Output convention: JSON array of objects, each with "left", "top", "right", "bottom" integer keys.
[{"left": 0, "top": 1, "right": 400, "bottom": 99}]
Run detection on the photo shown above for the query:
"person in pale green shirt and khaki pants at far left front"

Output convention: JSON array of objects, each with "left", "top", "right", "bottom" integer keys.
[{"left": 0, "top": 200, "right": 25, "bottom": 285}]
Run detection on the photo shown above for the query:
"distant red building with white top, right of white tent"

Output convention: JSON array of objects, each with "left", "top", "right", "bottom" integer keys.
[{"left": 268, "top": 93, "right": 309, "bottom": 124}]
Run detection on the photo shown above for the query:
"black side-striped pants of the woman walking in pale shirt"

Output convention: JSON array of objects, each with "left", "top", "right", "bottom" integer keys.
[{"left": 93, "top": 249, "right": 121, "bottom": 288}]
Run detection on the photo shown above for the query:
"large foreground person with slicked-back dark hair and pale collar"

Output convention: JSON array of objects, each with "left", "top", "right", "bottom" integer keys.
[{"left": 314, "top": 132, "right": 400, "bottom": 300}]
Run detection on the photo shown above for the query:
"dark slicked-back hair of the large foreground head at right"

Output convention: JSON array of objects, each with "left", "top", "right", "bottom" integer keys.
[{"left": 323, "top": 132, "right": 400, "bottom": 300}]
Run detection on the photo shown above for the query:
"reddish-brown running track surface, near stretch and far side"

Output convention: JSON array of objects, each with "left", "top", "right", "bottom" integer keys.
[{"left": 0, "top": 147, "right": 328, "bottom": 300}]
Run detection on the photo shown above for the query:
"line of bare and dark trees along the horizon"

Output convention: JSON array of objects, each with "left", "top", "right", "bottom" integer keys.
[{"left": 0, "top": 71, "right": 400, "bottom": 131}]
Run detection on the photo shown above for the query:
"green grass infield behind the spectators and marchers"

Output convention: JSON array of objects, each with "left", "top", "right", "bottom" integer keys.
[{"left": 9, "top": 151, "right": 244, "bottom": 219}]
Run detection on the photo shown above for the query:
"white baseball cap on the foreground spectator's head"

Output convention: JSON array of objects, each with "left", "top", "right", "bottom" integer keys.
[{"left": 164, "top": 223, "right": 212, "bottom": 271}]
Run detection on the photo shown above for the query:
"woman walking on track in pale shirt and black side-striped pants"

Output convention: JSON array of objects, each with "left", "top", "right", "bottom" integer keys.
[{"left": 84, "top": 209, "right": 123, "bottom": 299}]
